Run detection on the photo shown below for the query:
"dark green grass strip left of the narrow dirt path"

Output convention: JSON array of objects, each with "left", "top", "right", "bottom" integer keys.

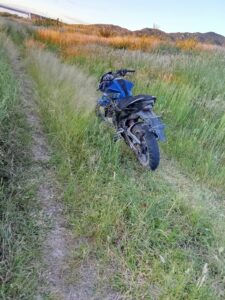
[{"left": 0, "top": 33, "right": 44, "bottom": 299}]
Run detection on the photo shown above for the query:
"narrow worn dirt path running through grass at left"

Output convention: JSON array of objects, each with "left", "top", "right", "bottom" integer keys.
[{"left": 6, "top": 41, "right": 121, "bottom": 300}]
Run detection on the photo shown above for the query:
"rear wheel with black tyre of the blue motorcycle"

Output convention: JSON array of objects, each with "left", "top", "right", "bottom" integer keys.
[{"left": 132, "top": 125, "right": 160, "bottom": 171}]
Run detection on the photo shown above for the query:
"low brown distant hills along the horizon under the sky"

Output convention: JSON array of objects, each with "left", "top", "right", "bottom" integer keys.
[{"left": 91, "top": 24, "right": 225, "bottom": 46}]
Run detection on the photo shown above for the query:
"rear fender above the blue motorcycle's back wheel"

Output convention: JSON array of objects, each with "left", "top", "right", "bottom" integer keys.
[{"left": 137, "top": 111, "right": 166, "bottom": 141}]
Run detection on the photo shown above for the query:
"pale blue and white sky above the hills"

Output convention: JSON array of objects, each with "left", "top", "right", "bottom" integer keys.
[{"left": 0, "top": 0, "right": 225, "bottom": 35}]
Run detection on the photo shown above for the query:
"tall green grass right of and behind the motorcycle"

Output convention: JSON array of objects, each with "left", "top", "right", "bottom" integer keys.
[{"left": 62, "top": 47, "right": 225, "bottom": 189}]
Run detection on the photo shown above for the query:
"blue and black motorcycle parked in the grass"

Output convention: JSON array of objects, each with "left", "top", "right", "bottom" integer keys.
[{"left": 96, "top": 69, "right": 165, "bottom": 171}]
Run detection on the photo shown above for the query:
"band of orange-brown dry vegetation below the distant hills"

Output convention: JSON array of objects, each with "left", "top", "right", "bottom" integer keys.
[{"left": 37, "top": 24, "right": 223, "bottom": 57}]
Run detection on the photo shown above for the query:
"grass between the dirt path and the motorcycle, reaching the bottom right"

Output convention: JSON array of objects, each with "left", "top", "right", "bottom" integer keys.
[{"left": 28, "top": 50, "right": 224, "bottom": 299}]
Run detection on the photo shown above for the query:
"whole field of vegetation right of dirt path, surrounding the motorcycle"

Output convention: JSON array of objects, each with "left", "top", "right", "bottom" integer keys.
[{"left": 1, "top": 17, "right": 225, "bottom": 299}]
